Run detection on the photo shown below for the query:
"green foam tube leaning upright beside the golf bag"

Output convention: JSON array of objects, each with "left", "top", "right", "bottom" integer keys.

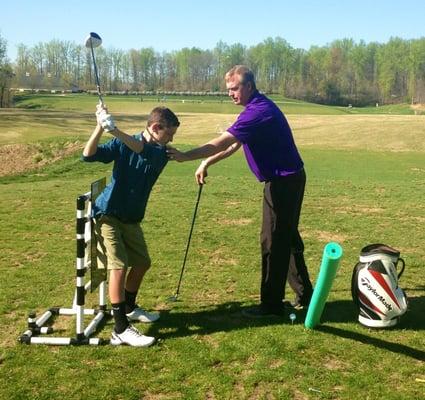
[{"left": 304, "top": 242, "right": 342, "bottom": 329}]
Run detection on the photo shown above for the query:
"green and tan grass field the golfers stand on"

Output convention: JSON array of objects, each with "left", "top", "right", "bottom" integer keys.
[{"left": 0, "top": 96, "right": 425, "bottom": 400}]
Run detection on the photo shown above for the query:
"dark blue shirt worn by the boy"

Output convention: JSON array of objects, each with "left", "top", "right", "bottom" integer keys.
[{"left": 83, "top": 134, "right": 168, "bottom": 223}]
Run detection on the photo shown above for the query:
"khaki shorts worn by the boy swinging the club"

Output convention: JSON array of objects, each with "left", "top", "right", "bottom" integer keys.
[{"left": 95, "top": 215, "right": 151, "bottom": 269}]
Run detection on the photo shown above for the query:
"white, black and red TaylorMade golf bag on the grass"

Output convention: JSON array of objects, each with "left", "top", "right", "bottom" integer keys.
[{"left": 351, "top": 243, "right": 407, "bottom": 328}]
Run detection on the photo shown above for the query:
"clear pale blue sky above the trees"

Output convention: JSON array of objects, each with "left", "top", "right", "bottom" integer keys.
[{"left": 0, "top": 0, "right": 425, "bottom": 61}]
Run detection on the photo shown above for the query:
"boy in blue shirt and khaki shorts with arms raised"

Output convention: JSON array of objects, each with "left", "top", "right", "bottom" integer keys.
[{"left": 83, "top": 97, "right": 180, "bottom": 347}]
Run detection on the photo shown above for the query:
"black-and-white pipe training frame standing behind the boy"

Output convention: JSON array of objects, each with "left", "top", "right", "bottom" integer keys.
[{"left": 19, "top": 178, "right": 111, "bottom": 346}]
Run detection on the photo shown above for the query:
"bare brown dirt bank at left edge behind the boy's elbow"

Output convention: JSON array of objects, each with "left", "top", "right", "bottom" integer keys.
[{"left": 0, "top": 141, "right": 82, "bottom": 176}]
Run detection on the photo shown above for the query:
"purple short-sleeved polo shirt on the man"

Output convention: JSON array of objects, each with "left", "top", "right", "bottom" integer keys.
[{"left": 227, "top": 91, "right": 304, "bottom": 182}]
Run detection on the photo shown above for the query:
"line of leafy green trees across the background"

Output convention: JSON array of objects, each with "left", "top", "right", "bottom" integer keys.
[{"left": 0, "top": 37, "right": 425, "bottom": 106}]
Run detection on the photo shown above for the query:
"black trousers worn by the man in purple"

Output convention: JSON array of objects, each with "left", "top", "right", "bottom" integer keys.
[{"left": 261, "top": 170, "right": 313, "bottom": 308}]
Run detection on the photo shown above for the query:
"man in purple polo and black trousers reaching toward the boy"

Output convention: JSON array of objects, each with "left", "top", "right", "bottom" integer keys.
[{"left": 168, "top": 65, "right": 313, "bottom": 317}]
